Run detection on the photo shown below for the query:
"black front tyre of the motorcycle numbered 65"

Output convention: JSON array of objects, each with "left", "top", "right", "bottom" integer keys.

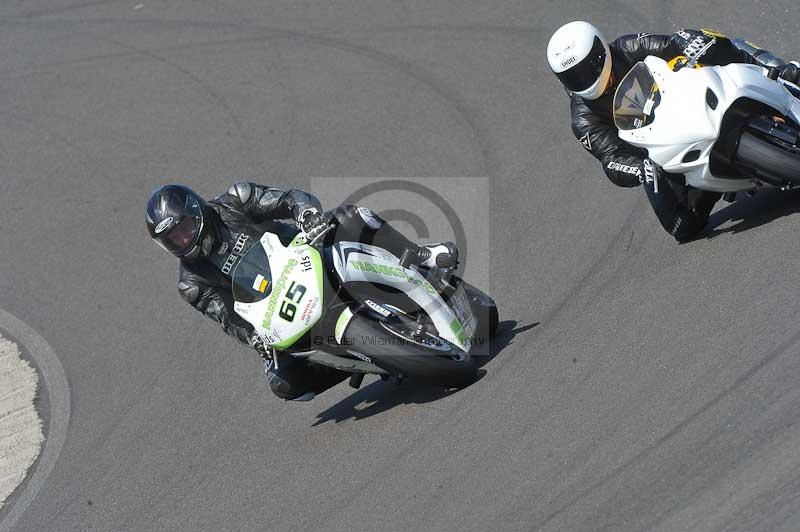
[{"left": 344, "top": 314, "right": 478, "bottom": 388}]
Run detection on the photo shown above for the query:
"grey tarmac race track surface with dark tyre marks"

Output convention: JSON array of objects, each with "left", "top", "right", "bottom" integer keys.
[{"left": 0, "top": 0, "right": 800, "bottom": 532}]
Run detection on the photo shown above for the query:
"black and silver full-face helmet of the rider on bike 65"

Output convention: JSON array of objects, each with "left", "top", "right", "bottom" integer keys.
[{"left": 145, "top": 185, "right": 213, "bottom": 259}]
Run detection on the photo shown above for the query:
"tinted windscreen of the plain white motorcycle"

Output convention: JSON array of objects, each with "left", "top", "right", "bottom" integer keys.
[{"left": 614, "top": 62, "right": 661, "bottom": 131}]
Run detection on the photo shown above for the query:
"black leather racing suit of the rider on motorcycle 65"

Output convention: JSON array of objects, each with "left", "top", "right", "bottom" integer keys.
[{"left": 178, "top": 182, "right": 416, "bottom": 399}]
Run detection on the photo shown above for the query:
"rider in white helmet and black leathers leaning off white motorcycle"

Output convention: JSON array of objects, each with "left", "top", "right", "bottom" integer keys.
[{"left": 547, "top": 21, "right": 800, "bottom": 242}]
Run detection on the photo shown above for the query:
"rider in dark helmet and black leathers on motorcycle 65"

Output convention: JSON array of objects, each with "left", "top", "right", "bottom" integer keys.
[{"left": 145, "top": 182, "right": 458, "bottom": 400}]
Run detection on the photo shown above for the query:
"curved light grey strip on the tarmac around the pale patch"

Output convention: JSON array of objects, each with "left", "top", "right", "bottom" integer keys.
[{"left": 0, "top": 308, "right": 70, "bottom": 532}]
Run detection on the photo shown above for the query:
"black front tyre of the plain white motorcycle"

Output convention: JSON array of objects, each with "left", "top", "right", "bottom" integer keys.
[{"left": 736, "top": 131, "right": 800, "bottom": 185}]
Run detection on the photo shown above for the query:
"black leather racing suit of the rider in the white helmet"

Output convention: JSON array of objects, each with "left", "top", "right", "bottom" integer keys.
[{"left": 570, "top": 30, "right": 792, "bottom": 242}]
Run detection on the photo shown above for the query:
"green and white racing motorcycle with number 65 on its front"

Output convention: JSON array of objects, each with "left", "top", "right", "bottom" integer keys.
[{"left": 228, "top": 226, "right": 498, "bottom": 388}]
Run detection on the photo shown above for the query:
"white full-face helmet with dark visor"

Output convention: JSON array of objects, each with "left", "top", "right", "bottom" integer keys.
[{"left": 547, "top": 20, "right": 611, "bottom": 100}]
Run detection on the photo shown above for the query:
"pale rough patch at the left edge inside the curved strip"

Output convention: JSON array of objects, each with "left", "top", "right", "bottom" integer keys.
[{"left": 0, "top": 335, "right": 44, "bottom": 508}]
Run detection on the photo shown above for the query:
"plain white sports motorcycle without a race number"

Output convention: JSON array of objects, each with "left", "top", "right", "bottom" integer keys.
[{"left": 614, "top": 56, "right": 800, "bottom": 193}]
